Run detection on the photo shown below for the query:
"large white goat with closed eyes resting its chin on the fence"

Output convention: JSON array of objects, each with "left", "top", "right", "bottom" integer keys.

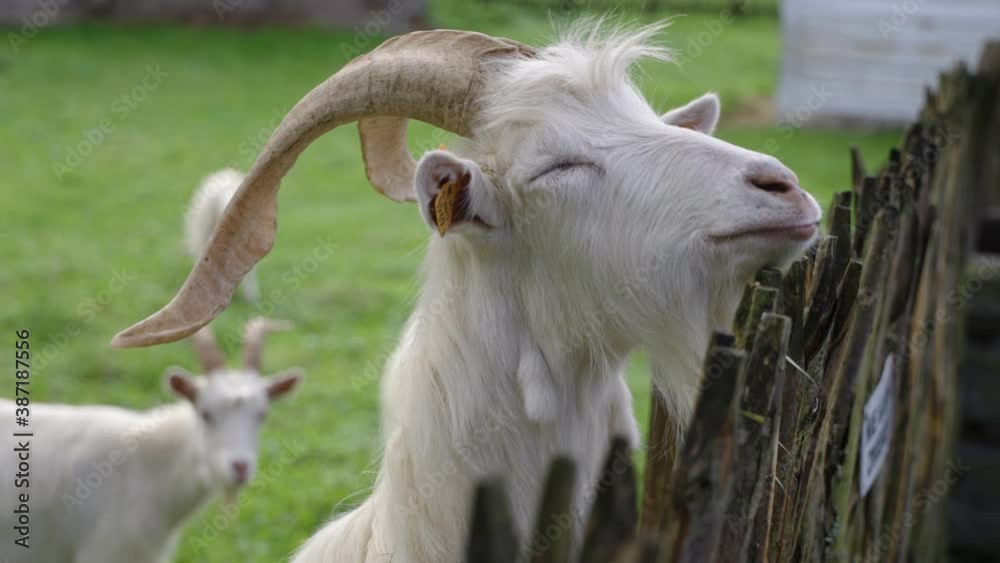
[{"left": 113, "top": 22, "right": 820, "bottom": 563}]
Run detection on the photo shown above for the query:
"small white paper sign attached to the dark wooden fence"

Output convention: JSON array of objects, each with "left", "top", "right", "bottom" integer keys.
[{"left": 858, "top": 354, "right": 893, "bottom": 497}]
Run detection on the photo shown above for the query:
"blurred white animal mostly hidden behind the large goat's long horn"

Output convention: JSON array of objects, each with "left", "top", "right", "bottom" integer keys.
[{"left": 184, "top": 168, "right": 260, "bottom": 303}]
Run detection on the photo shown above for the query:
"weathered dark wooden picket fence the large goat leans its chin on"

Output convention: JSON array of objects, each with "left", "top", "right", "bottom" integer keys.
[{"left": 460, "top": 43, "right": 1000, "bottom": 563}]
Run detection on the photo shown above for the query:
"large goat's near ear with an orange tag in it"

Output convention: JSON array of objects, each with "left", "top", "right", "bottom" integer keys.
[{"left": 415, "top": 150, "right": 506, "bottom": 236}]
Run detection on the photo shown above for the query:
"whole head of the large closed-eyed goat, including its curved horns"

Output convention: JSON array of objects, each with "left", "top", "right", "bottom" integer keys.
[{"left": 113, "top": 23, "right": 820, "bottom": 410}]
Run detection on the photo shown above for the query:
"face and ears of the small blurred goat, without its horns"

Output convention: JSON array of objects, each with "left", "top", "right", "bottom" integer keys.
[{"left": 167, "top": 368, "right": 302, "bottom": 489}]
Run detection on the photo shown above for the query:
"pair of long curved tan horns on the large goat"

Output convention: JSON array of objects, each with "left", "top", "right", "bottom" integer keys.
[{"left": 111, "top": 30, "right": 534, "bottom": 348}]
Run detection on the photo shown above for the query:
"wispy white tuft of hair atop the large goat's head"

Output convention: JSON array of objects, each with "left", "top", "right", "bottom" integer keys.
[{"left": 481, "top": 17, "right": 673, "bottom": 131}]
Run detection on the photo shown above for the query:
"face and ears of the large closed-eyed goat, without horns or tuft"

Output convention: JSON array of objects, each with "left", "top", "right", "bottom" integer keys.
[{"left": 416, "top": 88, "right": 820, "bottom": 346}]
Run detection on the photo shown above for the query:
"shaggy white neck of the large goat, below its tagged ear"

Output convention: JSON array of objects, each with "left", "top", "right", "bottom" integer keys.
[{"left": 383, "top": 240, "right": 634, "bottom": 524}]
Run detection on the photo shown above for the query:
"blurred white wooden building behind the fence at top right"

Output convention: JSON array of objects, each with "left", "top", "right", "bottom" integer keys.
[{"left": 776, "top": 0, "right": 1000, "bottom": 126}]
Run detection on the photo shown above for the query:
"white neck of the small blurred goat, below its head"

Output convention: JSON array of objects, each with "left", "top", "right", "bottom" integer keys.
[{"left": 134, "top": 403, "right": 215, "bottom": 532}]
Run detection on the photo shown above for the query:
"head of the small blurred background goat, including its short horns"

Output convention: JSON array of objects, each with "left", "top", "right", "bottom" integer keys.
[{"left": 165, "top": 318, "right": 303, "bottom": 489}]
